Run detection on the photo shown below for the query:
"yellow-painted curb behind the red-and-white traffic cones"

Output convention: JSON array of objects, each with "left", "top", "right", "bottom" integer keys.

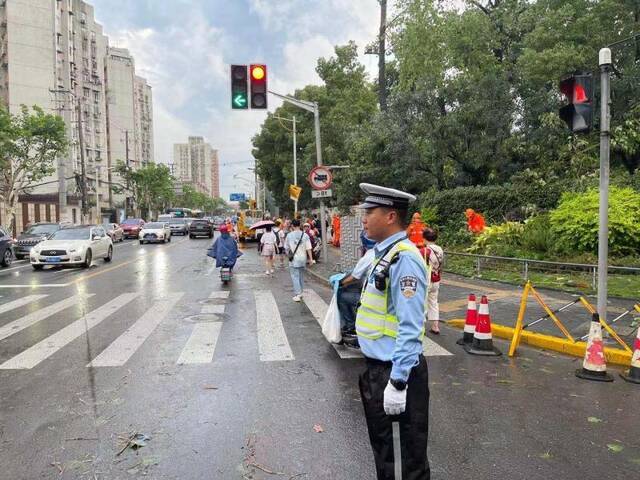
[{"left": 446, "top": 319, "right": 631, "bottom": 367}]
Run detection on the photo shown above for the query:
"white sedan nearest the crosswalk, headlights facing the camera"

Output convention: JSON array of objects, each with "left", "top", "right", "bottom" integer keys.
[{"left": 29, "top": 225, "right": 113, "bottom": 270}]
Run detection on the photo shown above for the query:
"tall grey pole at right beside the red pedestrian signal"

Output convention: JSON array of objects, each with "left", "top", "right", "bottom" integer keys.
[{"left": 598, "top": 48, "right": 612, "bottom": 322}]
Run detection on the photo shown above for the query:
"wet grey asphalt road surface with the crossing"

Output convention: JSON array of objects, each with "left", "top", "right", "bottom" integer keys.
[{"left": 0, "top": 237, "right": 640, "bottom": 480}]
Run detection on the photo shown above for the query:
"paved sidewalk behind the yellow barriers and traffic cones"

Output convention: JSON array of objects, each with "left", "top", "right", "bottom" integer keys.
[{"left": 307, "top": 245, "right": 640, "bottom": 347}]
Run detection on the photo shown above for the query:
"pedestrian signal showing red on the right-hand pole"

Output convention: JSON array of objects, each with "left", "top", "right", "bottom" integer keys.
[{"left": 560, "top": 73, "right": 593, "bottom": 133}]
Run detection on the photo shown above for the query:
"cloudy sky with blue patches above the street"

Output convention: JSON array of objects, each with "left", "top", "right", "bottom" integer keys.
[{"left": 89, "top": 0, "right": 380, "bottom": 200}]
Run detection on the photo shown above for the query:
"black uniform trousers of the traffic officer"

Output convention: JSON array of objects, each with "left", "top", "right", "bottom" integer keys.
[{"left": 359, "top": 355, "right": 431, "bottom": 480}]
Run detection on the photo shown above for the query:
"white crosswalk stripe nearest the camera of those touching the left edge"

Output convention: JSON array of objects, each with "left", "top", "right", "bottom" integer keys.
[{"left": 0, "top": 293, "right": 139, "bottom": 370}]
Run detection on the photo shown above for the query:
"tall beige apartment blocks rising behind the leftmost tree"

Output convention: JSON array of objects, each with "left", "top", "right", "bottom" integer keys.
[{"left": 0, "top": 0, "right": 153, "bottom": 229}]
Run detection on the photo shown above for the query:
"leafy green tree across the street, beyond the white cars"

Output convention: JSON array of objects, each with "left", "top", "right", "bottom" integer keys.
[{"left": 115, "top": 161, "right": 175, "bottom": 218}]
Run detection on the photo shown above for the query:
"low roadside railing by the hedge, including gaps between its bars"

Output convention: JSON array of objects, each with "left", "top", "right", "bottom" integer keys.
[{"left": 444, "top": 251, "right": 640, "bottom": 290}]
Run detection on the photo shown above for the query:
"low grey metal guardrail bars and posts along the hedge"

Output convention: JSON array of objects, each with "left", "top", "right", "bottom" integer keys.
[{"left": 444, "top": 251, "right": 640, "bottom": 289}]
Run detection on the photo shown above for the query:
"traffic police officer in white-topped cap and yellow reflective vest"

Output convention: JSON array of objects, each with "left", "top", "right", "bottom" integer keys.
[{"left": 356, "top": 183, "right": 430, "bottom": 480}]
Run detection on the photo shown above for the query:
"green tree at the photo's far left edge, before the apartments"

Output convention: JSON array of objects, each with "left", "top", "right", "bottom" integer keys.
[{"left": 0, "top": 105, "right": 67, "bottom": 233}]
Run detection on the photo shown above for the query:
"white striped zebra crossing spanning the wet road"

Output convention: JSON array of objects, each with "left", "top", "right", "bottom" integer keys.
[{"left": 0, "top": 289, "right": 452, "bottom": 371}]
